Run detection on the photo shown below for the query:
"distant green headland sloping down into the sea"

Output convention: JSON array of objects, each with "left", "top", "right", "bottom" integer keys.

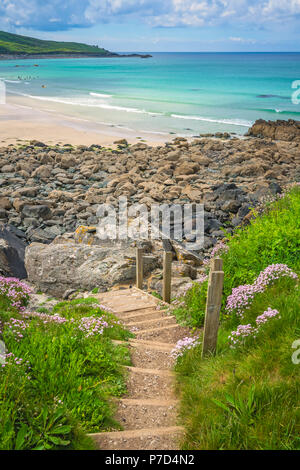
[{"left": 0, "top": 31, "right": 112, "bottom": 56}]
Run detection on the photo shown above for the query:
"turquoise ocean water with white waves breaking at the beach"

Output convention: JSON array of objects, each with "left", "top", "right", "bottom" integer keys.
[{"left": 0, "top": 53, "right": 300, "bottom": 136}]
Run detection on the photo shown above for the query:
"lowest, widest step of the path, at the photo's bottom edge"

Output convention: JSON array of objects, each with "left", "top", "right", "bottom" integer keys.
[{"left": 90, "top": 426, "right": 184, "bottom": 450}]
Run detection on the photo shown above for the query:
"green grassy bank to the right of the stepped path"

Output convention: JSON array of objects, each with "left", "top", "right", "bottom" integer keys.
[{"left": 176, "top": 187, "right": 300, "bottom": 450}]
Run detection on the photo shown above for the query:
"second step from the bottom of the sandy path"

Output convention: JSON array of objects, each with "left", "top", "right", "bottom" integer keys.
[{"left": 115, "top": 398, "right": 178, "bottom": 430}]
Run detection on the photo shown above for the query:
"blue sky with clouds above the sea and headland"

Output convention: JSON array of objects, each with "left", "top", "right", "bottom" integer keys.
[{"left": 0, "top": 0, "right": 300, "bottom": 52}]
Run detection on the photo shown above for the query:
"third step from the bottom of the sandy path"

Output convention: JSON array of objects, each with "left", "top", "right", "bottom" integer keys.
[{"left": 126, "top": 366, "right": 174, "bottom": 399}]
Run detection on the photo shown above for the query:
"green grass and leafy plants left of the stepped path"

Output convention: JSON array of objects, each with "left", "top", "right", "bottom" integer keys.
[{"left": 0, "top": 296, "right": 132, "bottom": 450}]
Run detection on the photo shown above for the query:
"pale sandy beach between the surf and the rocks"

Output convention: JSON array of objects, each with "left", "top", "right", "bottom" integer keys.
[{"left": 0, "top": 95, "right": 172, "bottom": 147}]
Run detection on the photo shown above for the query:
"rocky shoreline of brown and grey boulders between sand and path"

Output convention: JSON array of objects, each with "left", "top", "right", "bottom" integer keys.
[{"left": 0, "top": 121, "right": 300, "bottom": 296}]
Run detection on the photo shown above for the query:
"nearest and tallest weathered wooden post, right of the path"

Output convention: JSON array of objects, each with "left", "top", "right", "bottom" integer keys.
[{"left": 202, "top": 258, "right": 224, "bottom": 357}]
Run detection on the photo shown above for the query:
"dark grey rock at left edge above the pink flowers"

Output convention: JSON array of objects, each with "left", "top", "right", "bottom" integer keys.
[{"left": 0, "top": 224, "right": 27, "bottom": 279}]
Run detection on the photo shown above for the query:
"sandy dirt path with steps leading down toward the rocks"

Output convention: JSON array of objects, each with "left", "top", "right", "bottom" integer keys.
[{"left": 91, "top": 288, "right": 188, "bottom": 450}]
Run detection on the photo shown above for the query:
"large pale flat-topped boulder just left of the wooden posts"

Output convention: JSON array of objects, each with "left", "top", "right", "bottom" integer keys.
[{"left": 25, "top": 243, "right": 157, "bottom": 296}]
